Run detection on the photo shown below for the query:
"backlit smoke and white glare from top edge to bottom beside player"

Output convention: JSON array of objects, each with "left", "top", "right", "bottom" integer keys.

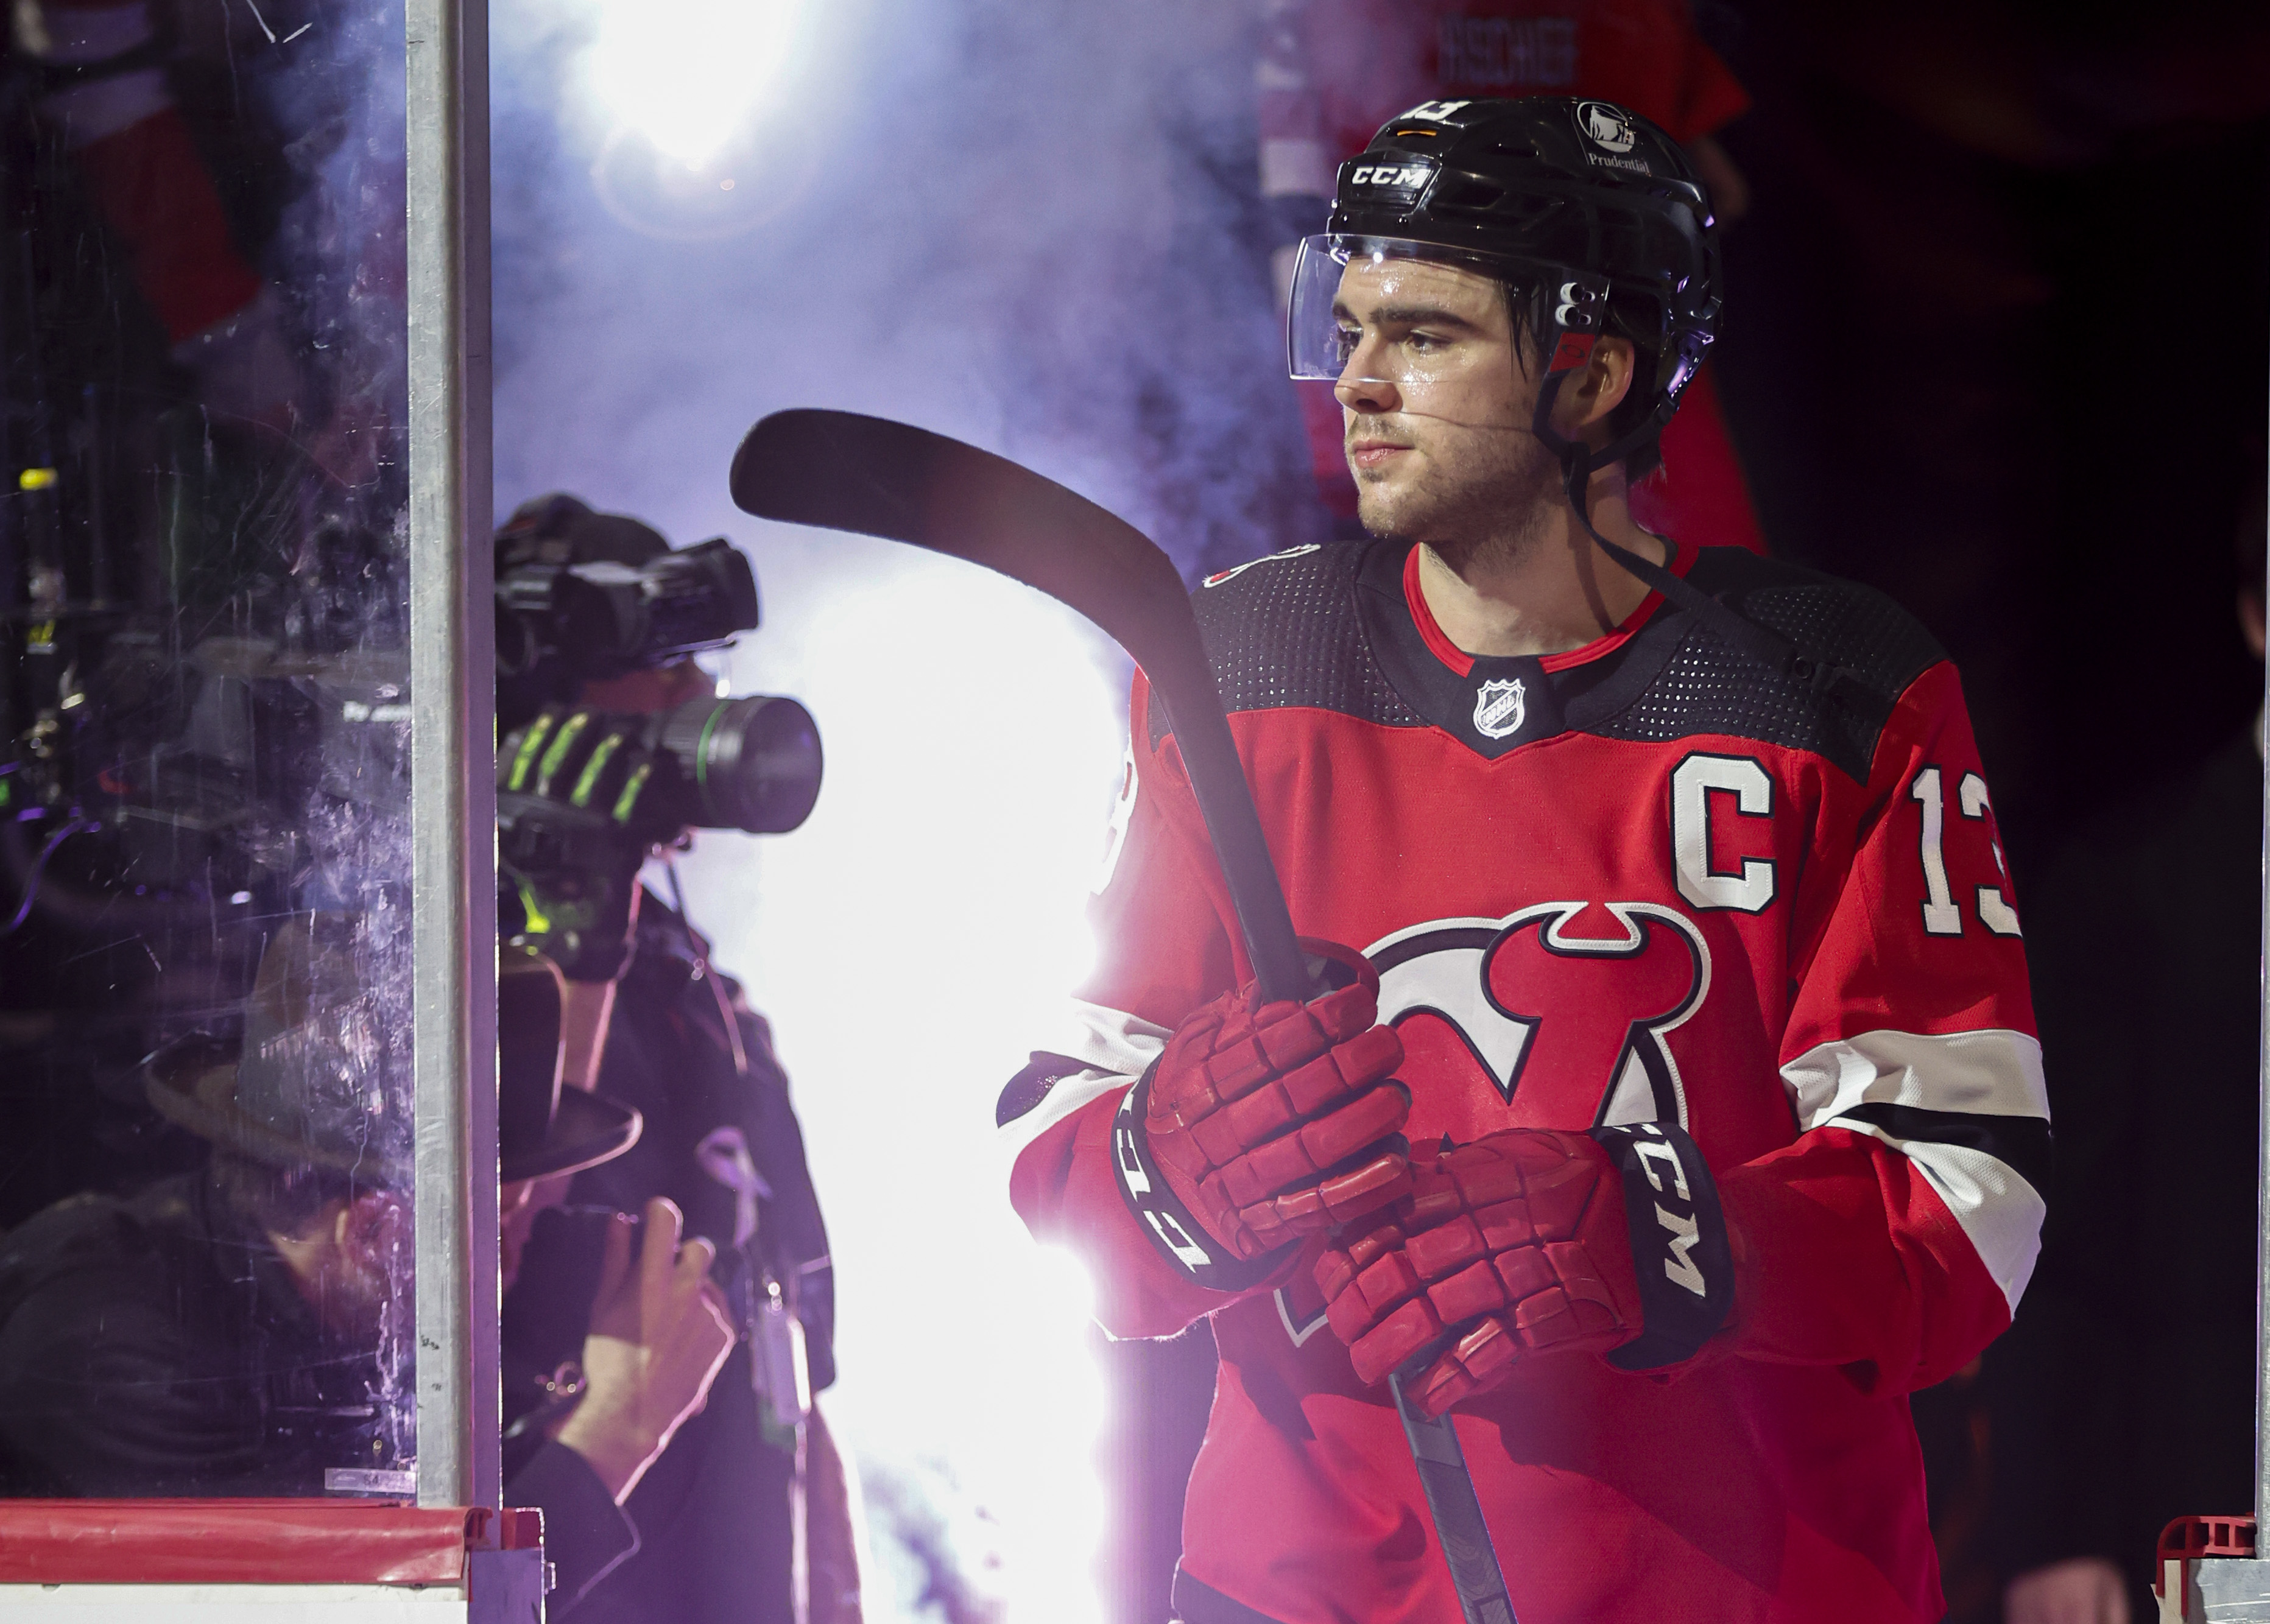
[{"left": 493, "top": 0, "right": 1324, "bottom": 1624}]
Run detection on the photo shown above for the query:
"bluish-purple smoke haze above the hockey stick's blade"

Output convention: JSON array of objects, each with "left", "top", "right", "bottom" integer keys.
[{"left": 495, "top": 0, "right": 1314, "bottom": 569}]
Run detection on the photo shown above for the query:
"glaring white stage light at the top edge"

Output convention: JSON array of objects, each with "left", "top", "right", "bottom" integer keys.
[{"left": 586, "top": 0, "right": 803, "bottom": 170}]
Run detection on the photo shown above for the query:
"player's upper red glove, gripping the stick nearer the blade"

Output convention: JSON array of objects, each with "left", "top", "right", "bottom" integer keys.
[{"left": 1112, "top": 941, "right": 1412, "bottom": 1290}]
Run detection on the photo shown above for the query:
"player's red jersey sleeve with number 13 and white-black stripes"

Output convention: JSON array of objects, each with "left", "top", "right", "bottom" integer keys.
[{"left": 1721, "top": 663, "right": 2050, "bottom": 1393}]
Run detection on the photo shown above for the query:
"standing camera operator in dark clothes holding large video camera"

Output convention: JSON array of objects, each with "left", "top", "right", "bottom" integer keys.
[{"left": 497, "top": 494, "right": 861, "bottom": 1624}]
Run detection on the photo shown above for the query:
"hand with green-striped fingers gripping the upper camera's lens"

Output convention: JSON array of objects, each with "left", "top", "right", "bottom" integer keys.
[{"left": 497, "top": 708, "right": 661, "bottom": 982}]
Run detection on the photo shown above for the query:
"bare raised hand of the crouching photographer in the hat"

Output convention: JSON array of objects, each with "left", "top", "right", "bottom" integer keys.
[{"left": 559, "top": 1195, "right": 733, "bottom": 1506}]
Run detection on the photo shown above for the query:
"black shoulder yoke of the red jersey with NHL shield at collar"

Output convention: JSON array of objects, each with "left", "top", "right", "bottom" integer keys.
[{"left": 1151, "top": 540, "right": 1945, "bottom": 780}]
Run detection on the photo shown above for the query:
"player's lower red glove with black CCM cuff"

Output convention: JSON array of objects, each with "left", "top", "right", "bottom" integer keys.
[{"left": 1317, "top": 1123, "right": 1734, "bottom": 1415}]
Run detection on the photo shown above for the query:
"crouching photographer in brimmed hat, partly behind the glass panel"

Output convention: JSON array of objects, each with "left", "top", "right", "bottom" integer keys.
[{"left": 0, "top": 914, "right": 733, "bottom": 1617}]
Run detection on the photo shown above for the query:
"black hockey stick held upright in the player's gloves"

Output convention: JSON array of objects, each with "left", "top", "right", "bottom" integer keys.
[{"left": 733, "top": 410, "right": 1514, "bottom": 1624}]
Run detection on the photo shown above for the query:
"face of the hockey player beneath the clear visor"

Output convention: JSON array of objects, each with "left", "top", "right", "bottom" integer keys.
[{"left": 1333, "top": 259, "right": 1557, "bottom": 556}]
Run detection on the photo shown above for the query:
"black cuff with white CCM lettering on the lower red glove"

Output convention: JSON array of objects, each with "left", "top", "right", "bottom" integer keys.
[{"left": 1591, "top": 1123, "right": 1734, "bottom": 1370}]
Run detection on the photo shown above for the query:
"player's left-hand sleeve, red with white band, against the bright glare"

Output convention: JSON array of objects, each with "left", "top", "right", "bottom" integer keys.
[{"left": 1001, "top": 673, "right": 1276, "bottom": 1336}]
